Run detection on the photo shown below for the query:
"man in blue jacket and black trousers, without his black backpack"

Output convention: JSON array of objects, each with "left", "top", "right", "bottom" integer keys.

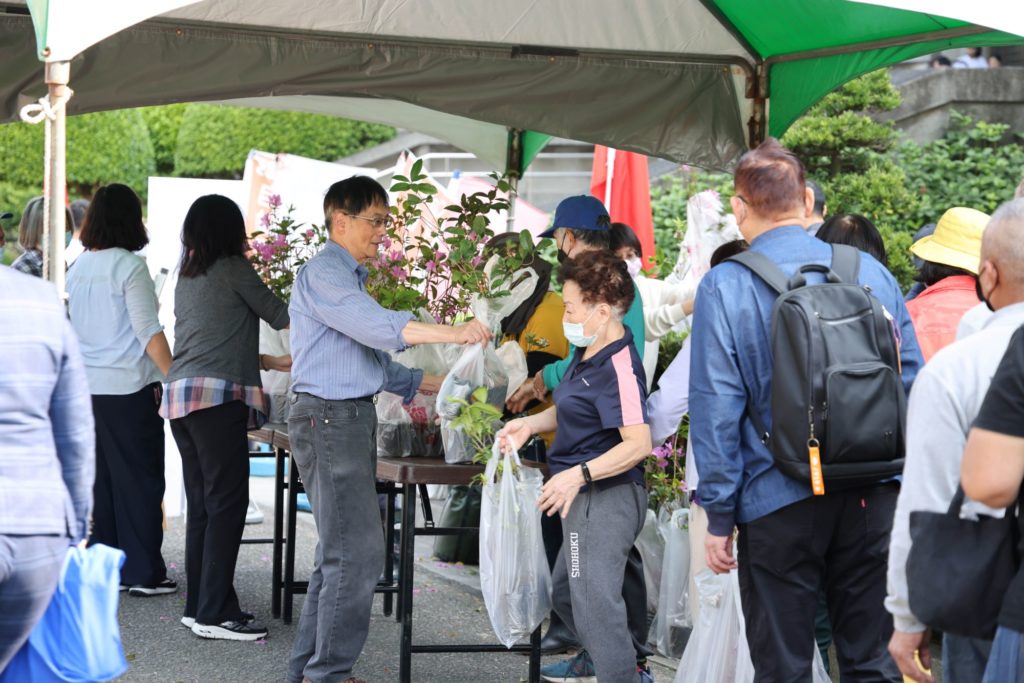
[{"left": 690, "top": 139, "right": 922, "bottom": 683}]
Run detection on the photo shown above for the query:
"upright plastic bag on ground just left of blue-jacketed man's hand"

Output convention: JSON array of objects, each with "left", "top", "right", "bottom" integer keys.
[{"left": 654, "top": 508, "right": 693, "bottom": 658}]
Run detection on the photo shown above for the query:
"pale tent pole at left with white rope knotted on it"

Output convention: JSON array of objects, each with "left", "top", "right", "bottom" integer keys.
[{"left": 43, "top": 61, "right": 72, "bottom": 297}]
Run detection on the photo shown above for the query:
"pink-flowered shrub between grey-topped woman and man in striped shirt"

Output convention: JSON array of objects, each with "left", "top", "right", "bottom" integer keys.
[{"left": 249, "top": 195, "right": 327, "bottom": 301}]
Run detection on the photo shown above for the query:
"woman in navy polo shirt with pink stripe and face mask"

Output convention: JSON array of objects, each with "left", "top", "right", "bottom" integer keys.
[{"left": 498, "top": 251, "right": 651, "bottom": 683}]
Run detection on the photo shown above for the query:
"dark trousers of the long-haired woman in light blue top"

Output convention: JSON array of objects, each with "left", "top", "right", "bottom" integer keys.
[{"left": 89, "top": 384, "right": 167, "bottom": 586}]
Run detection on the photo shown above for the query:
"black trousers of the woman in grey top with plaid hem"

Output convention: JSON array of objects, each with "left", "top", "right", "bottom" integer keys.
[{"left": 171, "top": 400, "right": 249, "bottom": 624}]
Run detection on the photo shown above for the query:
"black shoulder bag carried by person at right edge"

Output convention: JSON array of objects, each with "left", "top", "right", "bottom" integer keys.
[{"left": 906, "top": 486, "right": 1020, "bottom": 640}]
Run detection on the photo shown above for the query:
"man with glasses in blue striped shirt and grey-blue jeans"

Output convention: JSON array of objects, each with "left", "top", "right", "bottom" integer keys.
[{"left": 288, "top": 176, "right": 492, "bottom": 683}]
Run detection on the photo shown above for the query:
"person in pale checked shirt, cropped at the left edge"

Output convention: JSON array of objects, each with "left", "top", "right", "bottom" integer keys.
[{"left": 0, "top": 266, "right": 96, "bottom": 671}]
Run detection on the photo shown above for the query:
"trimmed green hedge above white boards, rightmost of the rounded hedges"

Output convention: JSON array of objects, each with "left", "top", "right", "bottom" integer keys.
[{"left": 174, "top": 104, "right": 394, "bottom": 178}]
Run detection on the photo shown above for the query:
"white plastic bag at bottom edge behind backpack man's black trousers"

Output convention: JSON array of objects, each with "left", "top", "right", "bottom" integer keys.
[{"left": 675, "top": 569, "right": 831, "bottom": 683}]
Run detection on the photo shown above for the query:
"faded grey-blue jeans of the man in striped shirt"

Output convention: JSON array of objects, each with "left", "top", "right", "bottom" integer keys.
[{"left": 288, "top": 393, "right": 384, "bottom": 683}]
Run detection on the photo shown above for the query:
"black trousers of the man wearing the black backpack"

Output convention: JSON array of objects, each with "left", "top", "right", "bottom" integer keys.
[{"left": 737, "top": 482, "right": 903, "bottom": 683}]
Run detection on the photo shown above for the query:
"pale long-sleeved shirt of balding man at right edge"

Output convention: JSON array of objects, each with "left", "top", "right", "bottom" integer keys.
[{"left": 886, "top": 303, "right": 1024, "bottom": 633}]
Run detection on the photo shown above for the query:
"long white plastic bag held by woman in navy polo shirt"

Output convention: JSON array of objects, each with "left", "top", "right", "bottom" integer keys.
[{"left": 480, "top": 440, "right": 551, "bottom": 647}]
